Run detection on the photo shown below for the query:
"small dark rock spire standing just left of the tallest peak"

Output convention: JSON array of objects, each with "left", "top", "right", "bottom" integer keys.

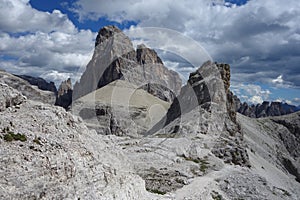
[{"left": 55, "top": 78, "right": 73, "bottom": 109}]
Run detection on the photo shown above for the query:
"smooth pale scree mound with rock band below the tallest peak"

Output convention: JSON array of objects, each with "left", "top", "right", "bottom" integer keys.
[{"left": 72, "top": 80, "right": 170, "bottom": 137}]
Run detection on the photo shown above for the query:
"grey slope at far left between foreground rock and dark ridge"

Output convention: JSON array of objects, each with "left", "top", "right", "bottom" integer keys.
[{"left": 0, "top": 71, "right": 56, "bottom": 104}]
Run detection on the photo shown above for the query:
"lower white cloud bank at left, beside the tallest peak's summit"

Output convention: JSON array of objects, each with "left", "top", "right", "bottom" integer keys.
[{"left": 0, "top": 30, "right": 94, "bottom": 84}]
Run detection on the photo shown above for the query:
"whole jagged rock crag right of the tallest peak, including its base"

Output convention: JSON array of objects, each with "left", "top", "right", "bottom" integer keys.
[{"left": 147, "top": 61, "right": 250, "bottom": 166}]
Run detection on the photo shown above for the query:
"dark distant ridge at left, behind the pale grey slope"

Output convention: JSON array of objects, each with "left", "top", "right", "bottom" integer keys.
[{"left": 15, "top": 74, "right": 57, "bottom": 94}]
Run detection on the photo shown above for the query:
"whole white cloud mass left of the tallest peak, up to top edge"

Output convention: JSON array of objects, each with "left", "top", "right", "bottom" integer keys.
[{"left": 0, "top": 0, "right": 95, "bottom": 85}]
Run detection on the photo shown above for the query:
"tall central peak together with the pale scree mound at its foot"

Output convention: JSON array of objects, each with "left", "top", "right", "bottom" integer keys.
[{"left": 72, "top": 26, "right": 181, "bottom": 136}]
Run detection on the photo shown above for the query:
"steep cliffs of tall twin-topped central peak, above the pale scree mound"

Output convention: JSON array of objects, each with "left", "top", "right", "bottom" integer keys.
[{"left": 73, "top": 26, "right": 181, "bottom": 102}]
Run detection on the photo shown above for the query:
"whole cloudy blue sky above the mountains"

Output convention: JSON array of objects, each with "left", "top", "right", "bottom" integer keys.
[{"left": 0, "top": 0, "right": 300, "bottom": 105}]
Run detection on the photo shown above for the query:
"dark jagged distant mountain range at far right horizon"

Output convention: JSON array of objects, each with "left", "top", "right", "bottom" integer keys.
[{"left": 235, "top": 98, "right": 300, "bottom": 118}]
